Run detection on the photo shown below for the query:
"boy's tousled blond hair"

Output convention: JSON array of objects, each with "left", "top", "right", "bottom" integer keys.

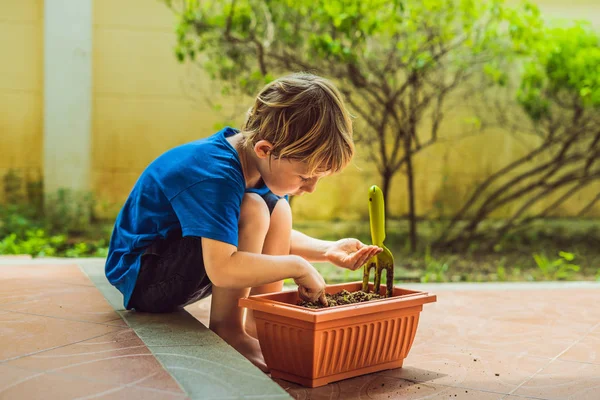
[{"left": 242, "top": 73, "right": 354, "bottom": 174}]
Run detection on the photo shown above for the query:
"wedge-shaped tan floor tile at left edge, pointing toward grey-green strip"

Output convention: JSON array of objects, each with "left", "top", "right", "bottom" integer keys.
[{"left": 0, "top": 312, "right": 122, "bottom": 361}]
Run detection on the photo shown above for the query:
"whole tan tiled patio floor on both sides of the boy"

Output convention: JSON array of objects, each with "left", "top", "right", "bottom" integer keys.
[{"left": 0, "top": 259, "right": 600, "bottom": 400}]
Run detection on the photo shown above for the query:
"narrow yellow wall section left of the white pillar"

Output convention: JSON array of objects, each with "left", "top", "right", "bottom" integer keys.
[{"left": 0, "top": 0, "right": 44, "bottom": 200}]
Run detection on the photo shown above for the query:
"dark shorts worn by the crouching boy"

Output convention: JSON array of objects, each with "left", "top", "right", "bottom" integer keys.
[{"left": 128, "top": 192, "right": 280, "bottom": 313}]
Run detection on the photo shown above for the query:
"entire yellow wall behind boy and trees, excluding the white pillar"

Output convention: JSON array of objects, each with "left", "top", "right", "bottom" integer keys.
[{"left": 0, "top": 0, "right": 600, "bottom": 219}]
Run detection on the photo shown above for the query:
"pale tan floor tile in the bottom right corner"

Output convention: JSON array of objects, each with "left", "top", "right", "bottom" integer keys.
[{"left": 513, "top": 360, "right": 600, "bottom": 400}]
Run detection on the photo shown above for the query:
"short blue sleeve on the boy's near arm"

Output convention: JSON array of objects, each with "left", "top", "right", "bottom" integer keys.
[{"left": 171, "top": 179, "right": 242, "bottom": 247}]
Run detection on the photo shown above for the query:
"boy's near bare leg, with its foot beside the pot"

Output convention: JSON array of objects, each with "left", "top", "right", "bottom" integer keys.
[{"left": 210, "top": 193, "right": 269, "bottom": 371}]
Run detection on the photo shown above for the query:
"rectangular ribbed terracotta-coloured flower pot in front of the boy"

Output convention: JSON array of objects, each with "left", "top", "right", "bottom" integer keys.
[{"left": 239, "top": 282, "right": 436, "bottom": 387}]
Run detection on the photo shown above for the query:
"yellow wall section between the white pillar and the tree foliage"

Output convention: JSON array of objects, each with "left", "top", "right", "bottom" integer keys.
[{"left": 92, "top": 0, "right": 210, "bottom": 216}]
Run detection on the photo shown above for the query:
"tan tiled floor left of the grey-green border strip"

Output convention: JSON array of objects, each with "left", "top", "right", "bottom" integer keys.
[{"left": 0, "top": 258, "right": 185, "bottom": 399}]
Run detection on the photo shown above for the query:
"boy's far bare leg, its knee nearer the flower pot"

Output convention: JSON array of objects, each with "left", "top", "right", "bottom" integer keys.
[{"left": 245, "top": 199, "right": 292, "bottom": 337}]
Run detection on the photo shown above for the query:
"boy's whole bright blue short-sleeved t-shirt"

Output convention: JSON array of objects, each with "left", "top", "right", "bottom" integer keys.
[{"left": 105, "top": 127, "right": 248, "bottom": 307}]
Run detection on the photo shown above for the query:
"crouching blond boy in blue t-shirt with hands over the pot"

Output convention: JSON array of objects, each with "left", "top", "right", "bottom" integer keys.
[{"left": 106, "top": 74, "right": 381, "bottom": 371}]
